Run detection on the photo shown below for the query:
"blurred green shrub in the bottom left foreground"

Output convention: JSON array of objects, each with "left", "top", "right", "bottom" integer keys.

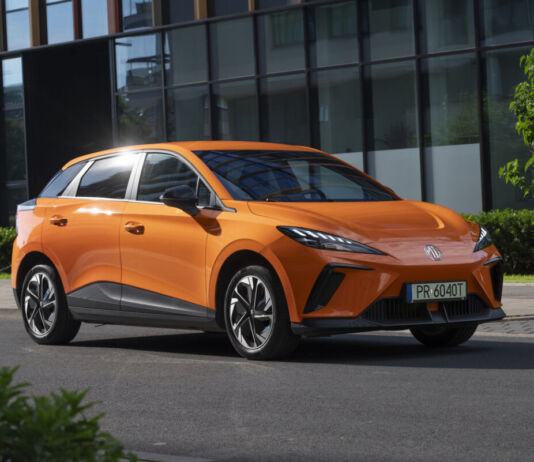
[{"left": 0, "top": 367, "right": 137, "bottom": 462}]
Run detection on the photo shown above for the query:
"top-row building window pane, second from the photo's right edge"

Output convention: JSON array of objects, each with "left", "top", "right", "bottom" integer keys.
[{"left": 419, "top": 0, "right": 475, "bottom": 53}]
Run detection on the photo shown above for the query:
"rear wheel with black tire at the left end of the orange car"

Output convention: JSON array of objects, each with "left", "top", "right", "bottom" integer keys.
[{"left": 20, "top": 265, "right": 81, "bottom": 345}]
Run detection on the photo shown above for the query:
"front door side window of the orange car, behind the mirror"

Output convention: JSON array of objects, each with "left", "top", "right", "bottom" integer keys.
[{"left": 137, "top": 154, "right": 198, "bottom": 202}]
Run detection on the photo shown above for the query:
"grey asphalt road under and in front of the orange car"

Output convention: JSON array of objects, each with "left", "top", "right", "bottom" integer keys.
[{"left": 0, "top": 312, "right": 534, "bottom": 461}]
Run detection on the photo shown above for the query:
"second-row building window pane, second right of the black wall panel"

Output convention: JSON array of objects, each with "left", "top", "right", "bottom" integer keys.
[{"left": 165, "top": 25, "right": 208, "bottom": 85}]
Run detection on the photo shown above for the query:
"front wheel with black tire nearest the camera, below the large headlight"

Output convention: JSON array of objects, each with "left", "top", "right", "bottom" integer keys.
[{"left": 224, "top": 265, "right": 299, "bottom": 360}]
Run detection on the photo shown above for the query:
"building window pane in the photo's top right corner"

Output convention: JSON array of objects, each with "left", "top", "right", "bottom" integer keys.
[{"left": 479, "top": 0, "right": 534, "bottom": 46}]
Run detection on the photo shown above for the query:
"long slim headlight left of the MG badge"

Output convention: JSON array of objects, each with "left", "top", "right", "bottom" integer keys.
[{"left": 277, "top": 226, "right": 386, "bottom": 255}]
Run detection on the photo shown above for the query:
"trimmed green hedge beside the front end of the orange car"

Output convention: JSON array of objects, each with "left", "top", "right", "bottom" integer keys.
[{"left": 464, "top": 209, "right": 534, "bottom": 274}]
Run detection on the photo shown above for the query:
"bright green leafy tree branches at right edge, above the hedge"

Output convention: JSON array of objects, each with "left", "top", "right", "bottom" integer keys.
[{"left": 499, "top": 48, "right": 534, "bottom": 197}]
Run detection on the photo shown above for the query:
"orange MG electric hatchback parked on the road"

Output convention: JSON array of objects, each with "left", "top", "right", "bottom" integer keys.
[{"left": 12, "top": 141, "right": 504, "bottom": 359}]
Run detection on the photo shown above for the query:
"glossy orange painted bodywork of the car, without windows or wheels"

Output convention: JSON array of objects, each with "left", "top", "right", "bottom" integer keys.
[{"left": 12, "top": 141, "right": 501, "bottom": 322}]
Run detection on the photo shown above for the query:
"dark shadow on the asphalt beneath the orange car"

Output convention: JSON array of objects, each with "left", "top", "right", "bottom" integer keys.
[{"left": 71, "top": 333, "right": 534, "bottom": 369}]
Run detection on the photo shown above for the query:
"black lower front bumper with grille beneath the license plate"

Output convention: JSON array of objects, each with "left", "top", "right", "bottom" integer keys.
[{"left": 291, "top": 294, "right": 505, "bottom": 336}]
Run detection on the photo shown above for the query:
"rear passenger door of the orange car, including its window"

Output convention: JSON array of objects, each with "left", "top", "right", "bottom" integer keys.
[{"left": 43, "top": 154, "right": 140, "bottom": 310}]
